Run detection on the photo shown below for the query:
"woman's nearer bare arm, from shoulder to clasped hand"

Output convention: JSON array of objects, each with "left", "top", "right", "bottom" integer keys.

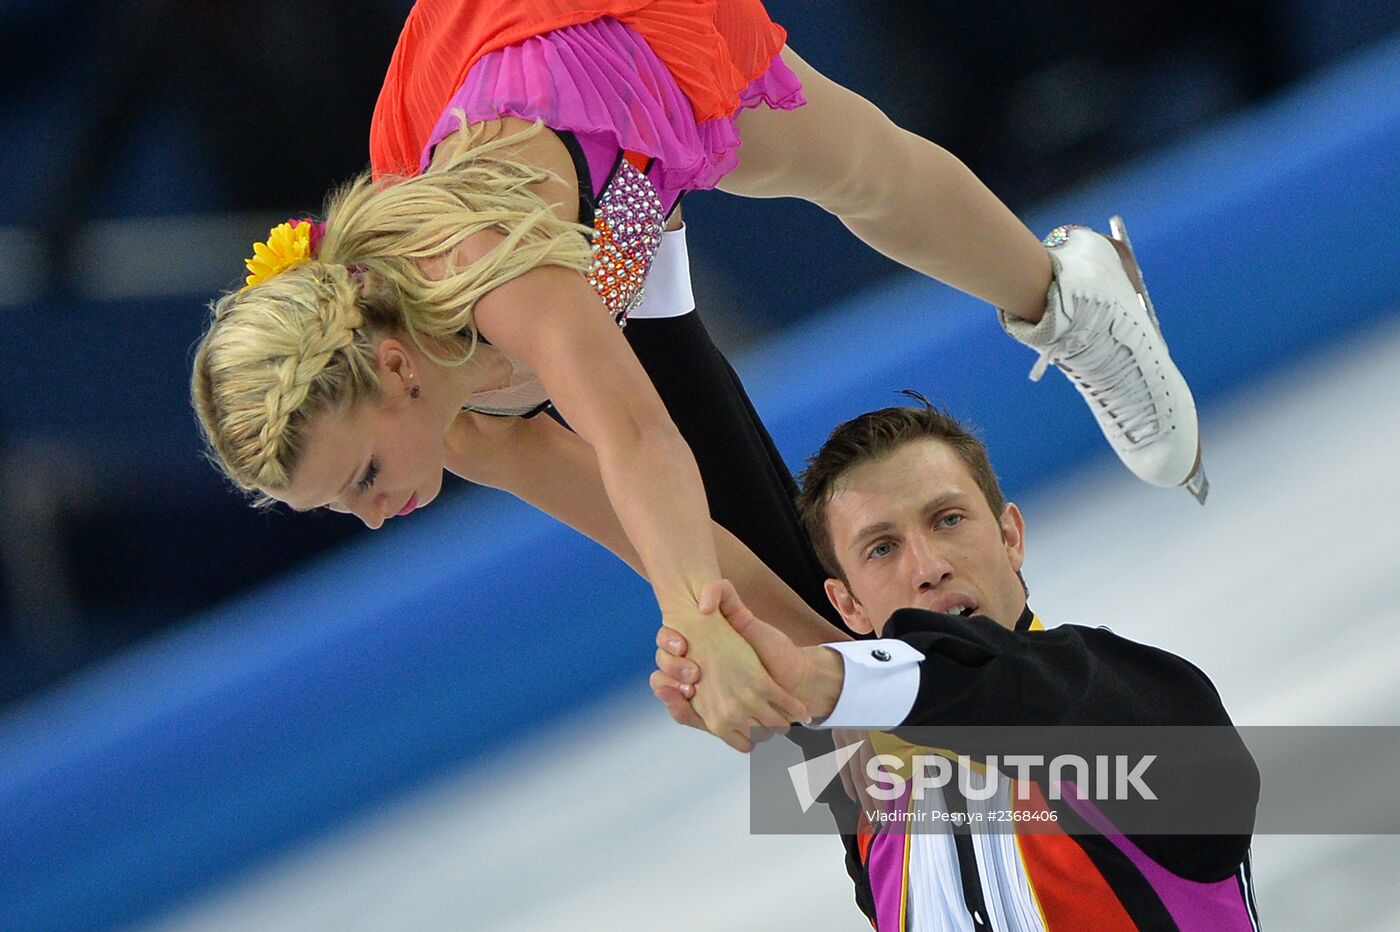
[{"left": 420, "top": 118, "right": 804, "bottom": 750}]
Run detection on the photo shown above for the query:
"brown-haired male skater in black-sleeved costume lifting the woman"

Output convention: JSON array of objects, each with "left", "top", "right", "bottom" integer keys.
[{"left": 652, "top": 399, "right": 1259, "bottom": 932}]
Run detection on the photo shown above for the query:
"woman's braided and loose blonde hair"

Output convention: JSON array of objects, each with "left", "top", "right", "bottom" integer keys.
[{"left": 190, "top": 122, "right": 592, "bottom": 505}]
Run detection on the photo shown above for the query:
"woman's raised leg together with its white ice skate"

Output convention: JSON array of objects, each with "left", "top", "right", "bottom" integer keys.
[{"left": 721, "top": 48, "right": 1208, "bottom": 492}]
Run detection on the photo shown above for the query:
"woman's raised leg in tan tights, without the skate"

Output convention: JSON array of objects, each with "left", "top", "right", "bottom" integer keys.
[{"left": 720, "top": 48, "right": 1050, "bottom": 320}]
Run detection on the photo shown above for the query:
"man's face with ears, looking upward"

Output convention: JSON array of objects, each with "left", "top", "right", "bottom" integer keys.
[{"left": 826, "top": 439, "right": 1026, "bottom": 634}]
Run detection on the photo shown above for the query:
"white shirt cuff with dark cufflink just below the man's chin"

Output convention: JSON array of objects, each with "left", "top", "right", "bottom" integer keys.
[{"left": 815, "top": 638, "right": 924, "bottom": 728}]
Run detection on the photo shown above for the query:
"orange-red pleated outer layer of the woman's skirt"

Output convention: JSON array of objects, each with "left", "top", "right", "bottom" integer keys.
[{"left": 370, "top": 0, "right": 787, "bottom": 176}]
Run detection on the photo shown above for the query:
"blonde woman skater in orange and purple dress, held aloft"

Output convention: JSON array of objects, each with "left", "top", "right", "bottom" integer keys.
[{"left": 193, "top": 0, "right": 1198, "bottom": 746}]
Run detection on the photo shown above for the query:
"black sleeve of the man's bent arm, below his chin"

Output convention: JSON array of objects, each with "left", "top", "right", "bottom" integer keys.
[{"left": 883, "top": 609, "right": 1259, "bottom": 883}]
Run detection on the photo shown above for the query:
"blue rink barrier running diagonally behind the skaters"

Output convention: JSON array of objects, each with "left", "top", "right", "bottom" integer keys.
[{"left": 8, "top": 32, "right": 1400, "bottom": 929}]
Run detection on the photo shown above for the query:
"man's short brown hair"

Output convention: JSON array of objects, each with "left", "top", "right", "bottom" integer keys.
[{"left": 797, "top": 390, "right": 1007, "bottom": 582}]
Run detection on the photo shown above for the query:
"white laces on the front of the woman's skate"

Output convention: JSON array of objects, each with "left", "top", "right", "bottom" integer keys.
[{"left": 1030, "top": 295, "right": 1162, "bottom": 446}]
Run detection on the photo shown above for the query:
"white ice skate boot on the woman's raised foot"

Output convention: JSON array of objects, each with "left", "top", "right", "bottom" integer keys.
[{"left": 997, "top": 217, "right": 1210, "bottom": 505}]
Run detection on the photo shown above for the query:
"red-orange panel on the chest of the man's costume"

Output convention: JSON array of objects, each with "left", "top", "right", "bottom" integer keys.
[{"left": 1016, "top": 784, "right": 1137, "bottom": 932}]
